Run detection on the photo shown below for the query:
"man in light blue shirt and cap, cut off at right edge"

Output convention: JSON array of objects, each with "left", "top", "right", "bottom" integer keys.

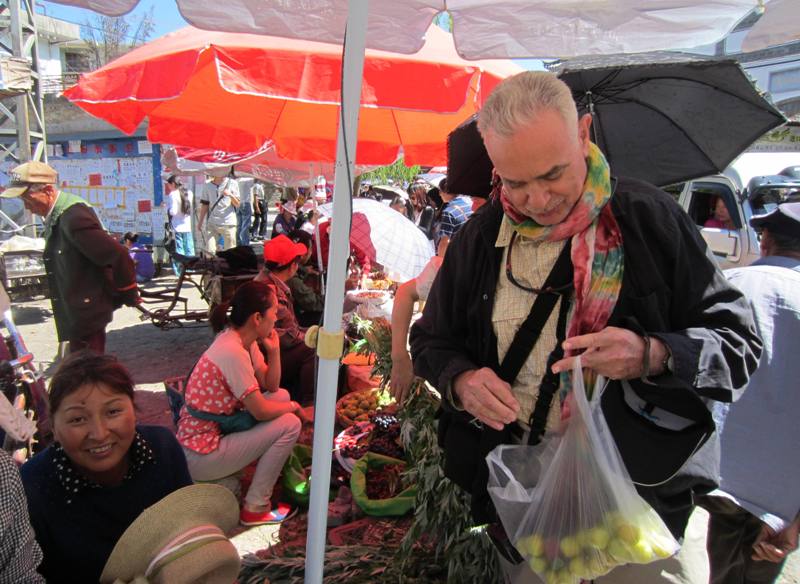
[{"left": 703, "top": 202, "right": 800, "bottom": 584}]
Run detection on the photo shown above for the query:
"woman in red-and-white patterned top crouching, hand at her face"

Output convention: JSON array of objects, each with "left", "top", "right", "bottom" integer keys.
[{"left": 178, "top": 282, "right": 305, "bottom": 525}]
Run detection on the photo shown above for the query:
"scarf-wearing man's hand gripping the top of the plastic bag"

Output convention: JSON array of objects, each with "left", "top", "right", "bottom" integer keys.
[{"left": 553, "top": 326, "right": 667, "bottom": 379}]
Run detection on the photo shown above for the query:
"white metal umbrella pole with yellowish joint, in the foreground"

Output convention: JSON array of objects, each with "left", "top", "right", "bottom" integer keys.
[{"left": 305, "top": 0, "right": 369, "bottom": 584}]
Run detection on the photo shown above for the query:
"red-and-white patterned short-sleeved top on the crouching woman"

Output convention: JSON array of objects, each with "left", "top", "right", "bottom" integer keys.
[{"left": 177, "top": 329, "right": 266, "bottom": 454}]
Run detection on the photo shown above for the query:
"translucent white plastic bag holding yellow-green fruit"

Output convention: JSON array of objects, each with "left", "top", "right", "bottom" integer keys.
[{"left": 486, "top": 359, "right": 679, "bottom": 584}]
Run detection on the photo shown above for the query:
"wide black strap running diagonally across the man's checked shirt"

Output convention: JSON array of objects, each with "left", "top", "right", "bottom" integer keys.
[{"left": 498, "top": 239, "right": 572, "bottom": 383}]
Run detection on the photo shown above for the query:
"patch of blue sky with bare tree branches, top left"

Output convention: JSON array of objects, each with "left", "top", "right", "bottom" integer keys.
[{"left": 81, "top": 6, "right": 155, "bottom": 68}]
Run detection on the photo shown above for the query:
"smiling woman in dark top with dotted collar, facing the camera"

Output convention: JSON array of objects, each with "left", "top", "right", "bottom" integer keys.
[{"left": 20, "top": 350, "right": 192, "bottom": 583}]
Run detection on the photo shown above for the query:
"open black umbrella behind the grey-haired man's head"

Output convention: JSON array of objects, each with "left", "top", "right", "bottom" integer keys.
[{"left": 448, "top": 53, "right": 786, "bottom": 192}]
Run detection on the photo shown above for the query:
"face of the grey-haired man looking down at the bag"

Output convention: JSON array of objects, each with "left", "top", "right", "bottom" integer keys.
[{"left": 484, "top": 110, "right": 592, "bottom": 225}]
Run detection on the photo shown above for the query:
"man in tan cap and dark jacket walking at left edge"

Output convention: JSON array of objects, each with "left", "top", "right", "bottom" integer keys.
[{"left": 0, "top": 161, "right": 140, "bottom": 353}]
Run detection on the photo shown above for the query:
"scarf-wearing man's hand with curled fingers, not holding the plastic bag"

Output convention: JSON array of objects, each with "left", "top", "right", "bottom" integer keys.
[{"left": 453, "top": 367, "right": 519, "bottom": 430}]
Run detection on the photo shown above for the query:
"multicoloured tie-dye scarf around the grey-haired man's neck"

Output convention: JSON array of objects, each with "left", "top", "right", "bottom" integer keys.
[{"left": 492, "top": 144, "right": 624, "bottom": 394}]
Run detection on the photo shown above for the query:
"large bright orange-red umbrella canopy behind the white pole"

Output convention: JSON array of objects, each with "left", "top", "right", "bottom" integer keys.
[{"left": 64, "top": 26, "right": 520, "bottom": 165}]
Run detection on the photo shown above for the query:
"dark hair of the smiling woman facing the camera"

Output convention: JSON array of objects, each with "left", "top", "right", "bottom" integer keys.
[{"left": 47, "top": 349, "right": 133, "bottom": 416}]
